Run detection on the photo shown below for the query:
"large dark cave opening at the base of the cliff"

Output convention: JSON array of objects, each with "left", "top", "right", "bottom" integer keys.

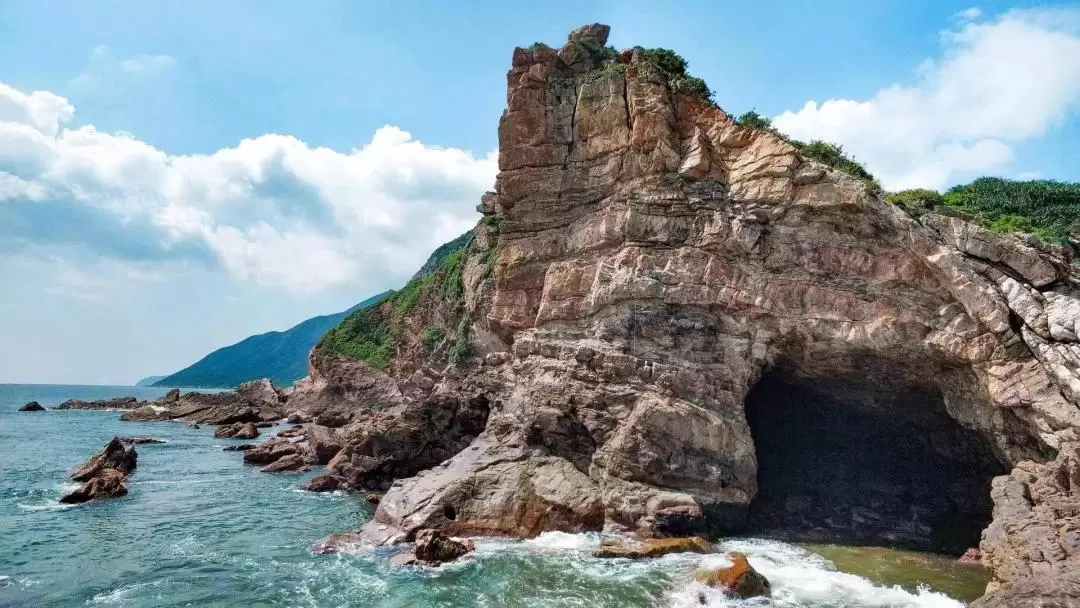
[{"left": 746, "top": 370, "right": 1007, "bottom": 554}]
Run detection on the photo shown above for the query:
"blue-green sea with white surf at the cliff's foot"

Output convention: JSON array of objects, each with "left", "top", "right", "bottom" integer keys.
[{"left": 0, "top": 384, "right": 986, "bottom": 608}]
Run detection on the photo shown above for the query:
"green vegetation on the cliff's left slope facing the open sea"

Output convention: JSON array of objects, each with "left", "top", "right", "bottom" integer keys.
[{"left": 316, "top": 232, "right": 472, "bottom": 370}]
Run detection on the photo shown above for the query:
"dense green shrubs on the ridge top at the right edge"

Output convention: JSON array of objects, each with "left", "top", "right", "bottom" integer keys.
[{"left": 886, "top": 177, "right": 1080, "bottom": 245}]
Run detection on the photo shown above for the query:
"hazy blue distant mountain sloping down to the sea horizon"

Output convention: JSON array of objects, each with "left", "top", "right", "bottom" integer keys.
[{"left": 152, "top": 292, "right": 391, "bottom": 389}]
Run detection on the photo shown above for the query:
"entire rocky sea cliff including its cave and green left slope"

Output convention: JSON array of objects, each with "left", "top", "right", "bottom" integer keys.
[{"left": 291, "top": 25, "right": 1080, "bottom": 605}]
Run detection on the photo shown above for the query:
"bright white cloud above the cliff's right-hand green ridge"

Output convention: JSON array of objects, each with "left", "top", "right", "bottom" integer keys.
[{"left": 773, "top": 9, "right": 1080, "bottom": 189}]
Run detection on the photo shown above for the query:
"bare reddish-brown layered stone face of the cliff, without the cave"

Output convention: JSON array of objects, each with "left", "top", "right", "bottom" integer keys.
[{"left": 297, "top": 22, "right": 1080, "bottom": 604}]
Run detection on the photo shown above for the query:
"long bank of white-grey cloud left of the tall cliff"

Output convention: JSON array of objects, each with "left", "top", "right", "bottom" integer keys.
[{"left": 0, "top": 84, "right": 497, "bottom": 292}]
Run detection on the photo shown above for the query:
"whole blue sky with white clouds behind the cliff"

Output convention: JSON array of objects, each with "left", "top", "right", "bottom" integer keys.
[{"left": 0, "top": 0, "right": 1080, "bottom": 384}]
